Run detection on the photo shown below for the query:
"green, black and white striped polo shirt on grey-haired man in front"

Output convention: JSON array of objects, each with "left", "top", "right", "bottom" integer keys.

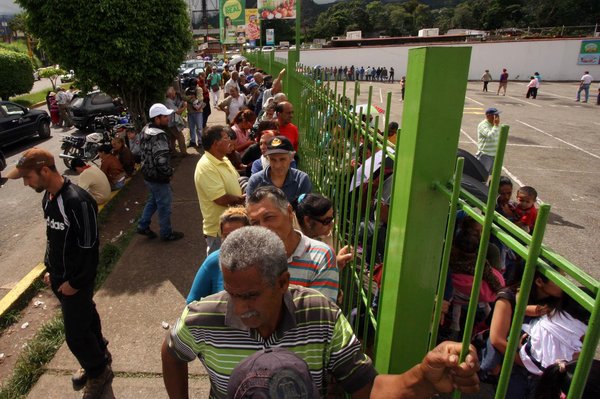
[{"left": 168, "top": 285, "right": 377, "bottom": 399}]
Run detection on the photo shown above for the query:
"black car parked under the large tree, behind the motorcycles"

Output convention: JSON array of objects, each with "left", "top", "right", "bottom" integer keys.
[{"left": 69, "top": 90, "right": 123, "bottom": 131}]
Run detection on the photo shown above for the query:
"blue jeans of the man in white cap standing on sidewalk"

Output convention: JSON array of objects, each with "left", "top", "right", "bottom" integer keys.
[{"left": 138, "top": 180, "right": 173, "bottom": 237}]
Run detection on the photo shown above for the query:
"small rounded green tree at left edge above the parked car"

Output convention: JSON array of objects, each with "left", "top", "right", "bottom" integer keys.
[{"left": 0, "top": 49, "right": 33, "bottom": 100}]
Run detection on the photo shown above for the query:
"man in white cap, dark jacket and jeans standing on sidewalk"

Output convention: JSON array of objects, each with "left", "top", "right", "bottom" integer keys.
[{"left": 137, "top": 103, "right": 183, "bottom": 241}]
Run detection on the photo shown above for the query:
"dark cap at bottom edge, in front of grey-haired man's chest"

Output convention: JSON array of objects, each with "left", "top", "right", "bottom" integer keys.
[{"left": 227, "top": 348, "right": 320, "bottom": 399}]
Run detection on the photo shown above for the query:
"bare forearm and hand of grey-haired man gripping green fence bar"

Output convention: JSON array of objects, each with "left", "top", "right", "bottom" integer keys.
[{"left": 371, "top": 342, "right": 479, "bottom": 399}]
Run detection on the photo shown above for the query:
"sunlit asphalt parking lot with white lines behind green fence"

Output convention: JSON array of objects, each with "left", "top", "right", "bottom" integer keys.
[{"left": 338, "top": 81, "right": 600, "bottom": 279}]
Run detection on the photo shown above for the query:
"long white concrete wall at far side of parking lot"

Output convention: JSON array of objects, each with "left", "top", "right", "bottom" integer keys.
[{"left": 276, "top": 39, "right": 600, "bottom": 82}]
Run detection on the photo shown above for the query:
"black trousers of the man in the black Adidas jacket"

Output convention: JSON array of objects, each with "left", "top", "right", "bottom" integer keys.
[{"left": 50, "top": 282, "right": 108, "bottom": 378}]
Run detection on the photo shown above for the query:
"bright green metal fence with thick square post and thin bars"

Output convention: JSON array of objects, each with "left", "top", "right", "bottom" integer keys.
[{"left": 247, "top": 47, "right": 600, "bottom": 399}]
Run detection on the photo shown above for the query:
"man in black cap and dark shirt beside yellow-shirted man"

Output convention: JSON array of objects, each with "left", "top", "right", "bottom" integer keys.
[{"left": 246, "top": 136, "right": 312, "bottom": 202}]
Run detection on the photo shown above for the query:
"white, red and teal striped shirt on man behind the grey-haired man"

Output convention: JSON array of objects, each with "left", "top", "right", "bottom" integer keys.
[{"left": 288, "top": 230, "right": 340, "bottom": 302}]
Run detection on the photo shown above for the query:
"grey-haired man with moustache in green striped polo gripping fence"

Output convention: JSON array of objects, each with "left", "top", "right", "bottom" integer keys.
[{"left": 161, "top": 226, "right": 479, "bottom": 399}]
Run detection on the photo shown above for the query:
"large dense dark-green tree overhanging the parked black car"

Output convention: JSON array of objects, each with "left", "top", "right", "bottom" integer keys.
[{"left": 17, "top": 0, "right": 192, "bottom": 126}]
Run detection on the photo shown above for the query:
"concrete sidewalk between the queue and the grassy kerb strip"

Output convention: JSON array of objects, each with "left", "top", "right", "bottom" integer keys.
[{"left": 28, "top": 108, "right": 225, "bottom": 399}]
